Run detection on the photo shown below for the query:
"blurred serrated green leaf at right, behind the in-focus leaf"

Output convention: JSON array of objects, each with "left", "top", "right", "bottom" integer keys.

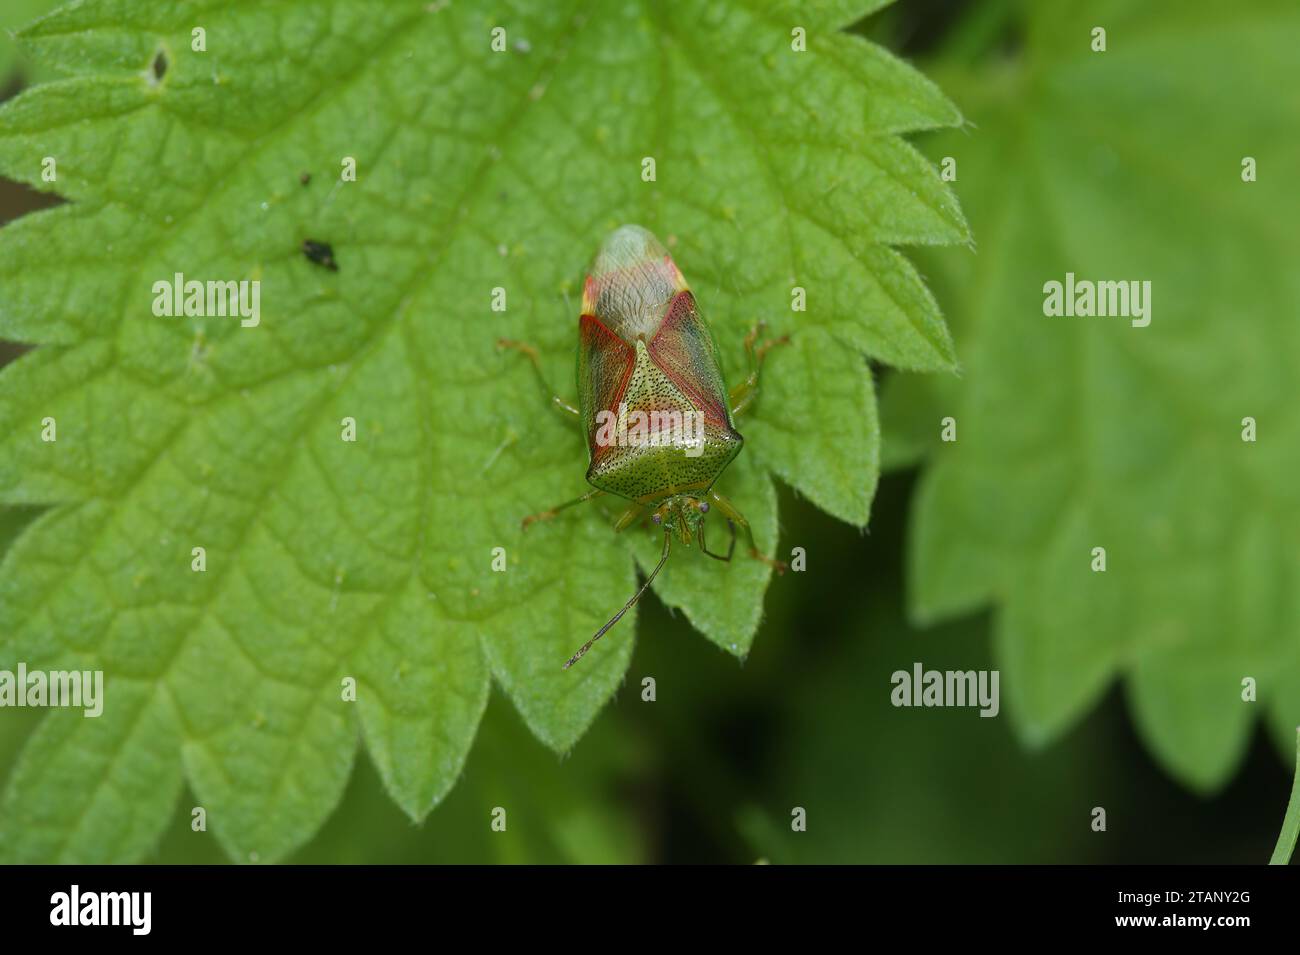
[{"left": 884, "top": 0, "right": 1300, "bottom": 790}]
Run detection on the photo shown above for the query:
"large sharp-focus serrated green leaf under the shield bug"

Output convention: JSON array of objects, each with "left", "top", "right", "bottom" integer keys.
[{"left": 0, "top": 0, "right": 967, "bottom": 861}]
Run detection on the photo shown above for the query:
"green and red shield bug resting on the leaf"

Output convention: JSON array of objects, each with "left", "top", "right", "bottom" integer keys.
[{"left": 499, "top": 225, "right": 788, "bottom": 669}]
